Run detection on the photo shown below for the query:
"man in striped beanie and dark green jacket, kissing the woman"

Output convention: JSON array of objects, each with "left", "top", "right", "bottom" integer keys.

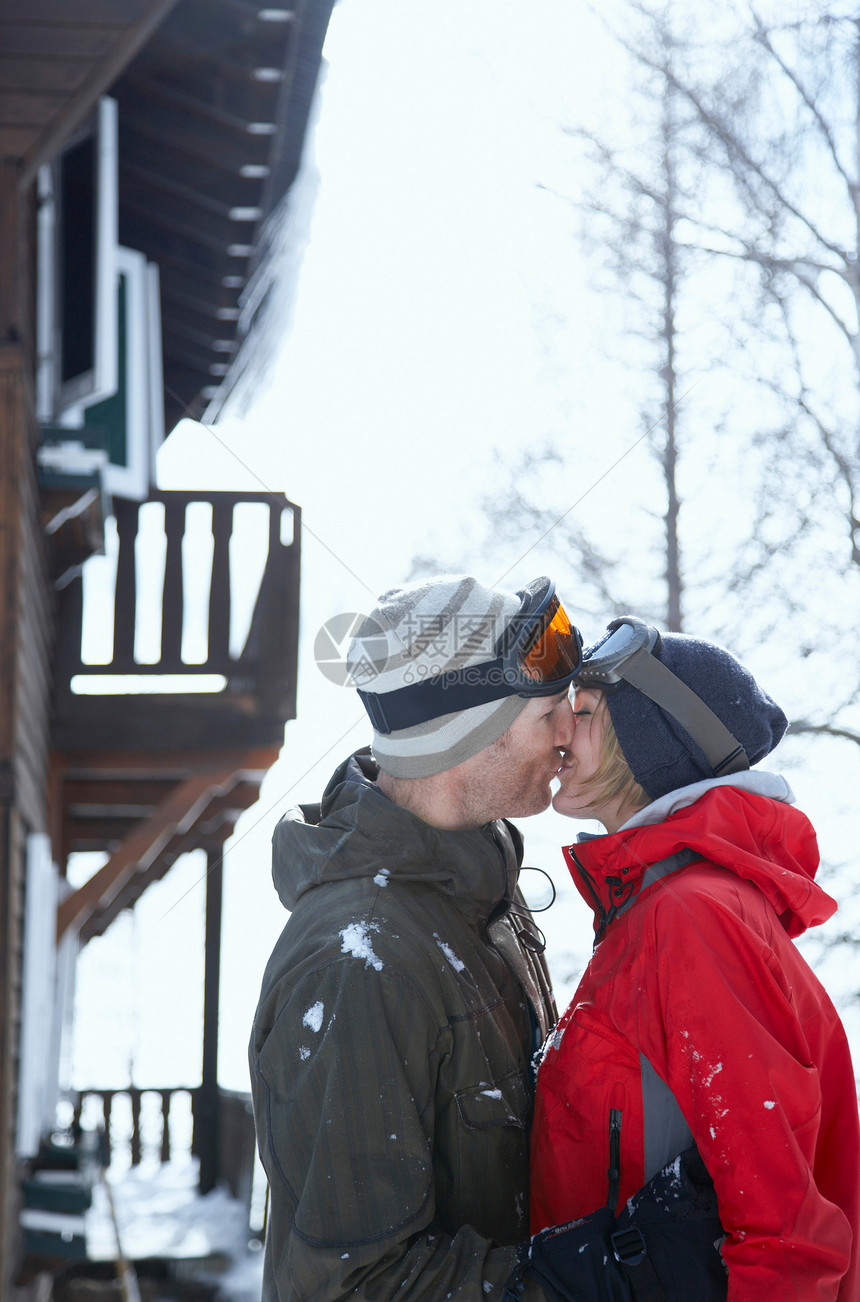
[{"left": 250, "top": 577, "right": 580, "bottom": 1302}]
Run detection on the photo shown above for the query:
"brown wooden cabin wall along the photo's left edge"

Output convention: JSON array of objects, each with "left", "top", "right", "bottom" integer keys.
[{"left": 0, "top": 165, "right": 52, "bottom": 1297}]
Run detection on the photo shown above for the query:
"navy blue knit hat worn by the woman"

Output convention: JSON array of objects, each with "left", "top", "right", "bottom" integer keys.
[{"left": 606, "top": 633, "right": 788, "bottom": 801}]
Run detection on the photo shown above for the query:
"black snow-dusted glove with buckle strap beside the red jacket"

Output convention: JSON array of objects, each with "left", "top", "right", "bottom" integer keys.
[{"left": 504, "top": 1146, "right": 729, "bottom": 1302}]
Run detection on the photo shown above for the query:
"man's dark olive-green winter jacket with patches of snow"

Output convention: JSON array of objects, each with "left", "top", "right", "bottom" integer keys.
[{"left": 250, "top": 753, "right": 556, "bottom": 1302}]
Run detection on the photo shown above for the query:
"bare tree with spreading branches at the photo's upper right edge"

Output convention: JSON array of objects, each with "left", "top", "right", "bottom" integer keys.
[{"left": 619, "top": 0, "right": 860, "bottom": 604}]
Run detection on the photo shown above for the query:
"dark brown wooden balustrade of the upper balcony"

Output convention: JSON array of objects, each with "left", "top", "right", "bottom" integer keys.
[{"left": 53, "top": 492, "right": 299, "bottom": 751}]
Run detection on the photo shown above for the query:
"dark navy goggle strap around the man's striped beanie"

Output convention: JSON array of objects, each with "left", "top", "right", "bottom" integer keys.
[{"left": 358, "top": 659, "right": 517, "bottom": 736}]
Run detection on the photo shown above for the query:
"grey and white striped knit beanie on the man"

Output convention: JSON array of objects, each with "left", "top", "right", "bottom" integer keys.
[{"left": 346, "top": 574, "right": 528, "bottom": 777}]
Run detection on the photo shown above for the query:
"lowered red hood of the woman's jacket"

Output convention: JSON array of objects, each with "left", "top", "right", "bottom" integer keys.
[{"left": 563, "top": 784, "right": 837, "bottom": 937}]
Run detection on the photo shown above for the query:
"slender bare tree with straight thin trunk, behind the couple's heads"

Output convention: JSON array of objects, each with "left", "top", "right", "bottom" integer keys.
[{"left": 485, "top": 10, "right": 749, "bottom": 631}]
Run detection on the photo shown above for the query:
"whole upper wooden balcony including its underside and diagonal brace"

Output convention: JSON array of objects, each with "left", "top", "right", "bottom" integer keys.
[{"left": 51, "top": 492, "right": 299, "bottom": 940}]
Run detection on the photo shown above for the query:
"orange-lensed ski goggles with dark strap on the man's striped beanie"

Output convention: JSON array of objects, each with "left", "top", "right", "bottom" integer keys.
[{"left": 358, "top": 578, "right": 583, "bottom": 734}]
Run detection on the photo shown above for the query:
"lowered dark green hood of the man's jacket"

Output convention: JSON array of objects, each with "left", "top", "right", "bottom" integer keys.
[{"left": 272, "top": 747, "right": 522, "bottom": 919}]
